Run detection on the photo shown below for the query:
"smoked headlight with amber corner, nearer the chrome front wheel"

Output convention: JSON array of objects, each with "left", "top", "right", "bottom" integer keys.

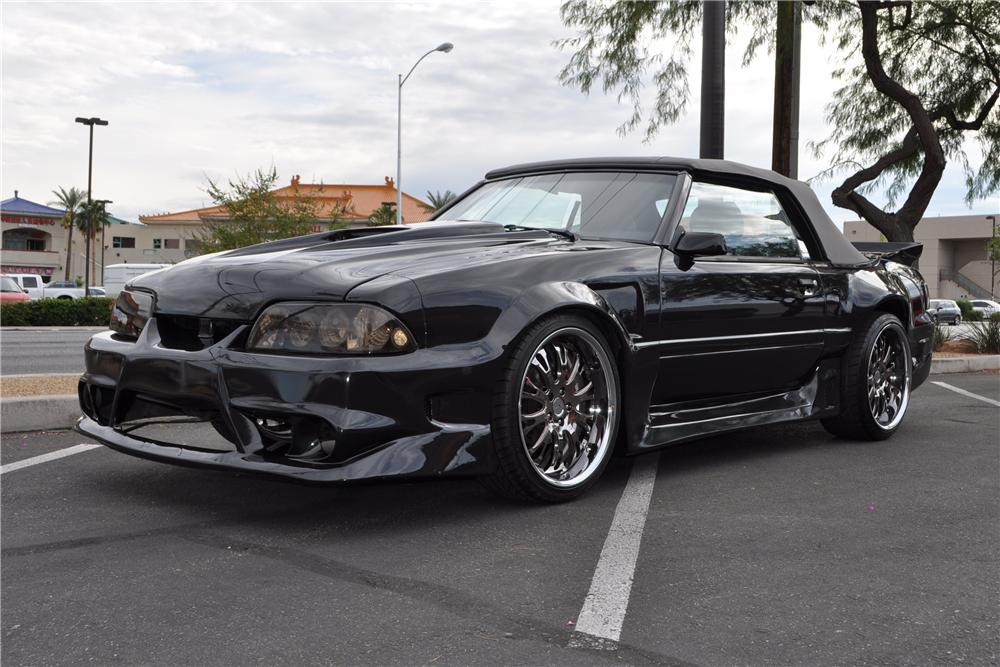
[{"left": 247, "top": 303, "right": 416, "bottom": 354}]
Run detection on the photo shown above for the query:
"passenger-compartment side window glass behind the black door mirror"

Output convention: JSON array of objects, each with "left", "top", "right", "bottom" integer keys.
[{"left": 680, "top": 183, "right": 808, "bottom": 258}]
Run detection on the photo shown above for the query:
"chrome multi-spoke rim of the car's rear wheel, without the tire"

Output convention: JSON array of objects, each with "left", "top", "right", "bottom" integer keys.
[{"left": 868, "top": 327, "right": 910, "bottom": 431}]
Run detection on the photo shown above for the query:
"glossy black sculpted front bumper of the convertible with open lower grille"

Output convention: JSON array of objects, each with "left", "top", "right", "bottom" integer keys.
[{"left": 77, "top": 319, "right": 499, "bottom": 483}]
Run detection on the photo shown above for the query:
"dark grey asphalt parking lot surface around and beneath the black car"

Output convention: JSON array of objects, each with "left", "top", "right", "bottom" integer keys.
[{"left": 0, "top": 374, "right": 1000, "bottom": 665}]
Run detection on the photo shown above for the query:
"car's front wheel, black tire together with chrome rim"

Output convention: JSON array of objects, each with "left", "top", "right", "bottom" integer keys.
[{"left": 482, "top": 314, "right": 621, "bottom": 503}]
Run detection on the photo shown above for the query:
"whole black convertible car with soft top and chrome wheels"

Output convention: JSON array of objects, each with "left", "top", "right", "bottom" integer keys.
[{"left": 78, "top": 158, "right": 933, "bottom": 501}]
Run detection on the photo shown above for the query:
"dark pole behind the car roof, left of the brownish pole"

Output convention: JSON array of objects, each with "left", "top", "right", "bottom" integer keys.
[{"left": 698, "top": 0, "right": 724, "bottom": 160}]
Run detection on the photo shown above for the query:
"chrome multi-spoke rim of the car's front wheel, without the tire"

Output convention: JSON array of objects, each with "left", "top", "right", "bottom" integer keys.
[{"left": 518, "top": 327, "right": 618, "bottom": 487}]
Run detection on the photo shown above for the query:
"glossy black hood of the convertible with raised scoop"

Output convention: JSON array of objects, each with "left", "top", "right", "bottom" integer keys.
[{"left": 131, "top": 222, "right": 567, "bottom": 321}]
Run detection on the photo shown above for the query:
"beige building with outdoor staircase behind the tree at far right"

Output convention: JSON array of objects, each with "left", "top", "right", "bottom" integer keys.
[{"left": 844, "top": 215, "right": 1000, "bottom": 299}]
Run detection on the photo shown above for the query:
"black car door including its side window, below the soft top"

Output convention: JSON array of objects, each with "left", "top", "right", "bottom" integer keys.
[{"left": 652, "top": 181, "right": 825, "bottom": 405}]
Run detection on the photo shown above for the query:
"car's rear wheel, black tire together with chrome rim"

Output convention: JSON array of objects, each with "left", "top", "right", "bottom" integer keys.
[{"left": 821, "top": 314, "right": 913, "bottom": 440}]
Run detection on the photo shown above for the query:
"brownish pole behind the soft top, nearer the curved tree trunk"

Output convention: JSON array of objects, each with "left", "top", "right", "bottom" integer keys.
[{"left": 771, "top": 0, "right": 802, "bottom": 178}]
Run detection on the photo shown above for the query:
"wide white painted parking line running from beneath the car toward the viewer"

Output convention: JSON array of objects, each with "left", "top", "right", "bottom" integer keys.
[{"left": 569, "top": 453, "right": 660, "bottom": 650}]
